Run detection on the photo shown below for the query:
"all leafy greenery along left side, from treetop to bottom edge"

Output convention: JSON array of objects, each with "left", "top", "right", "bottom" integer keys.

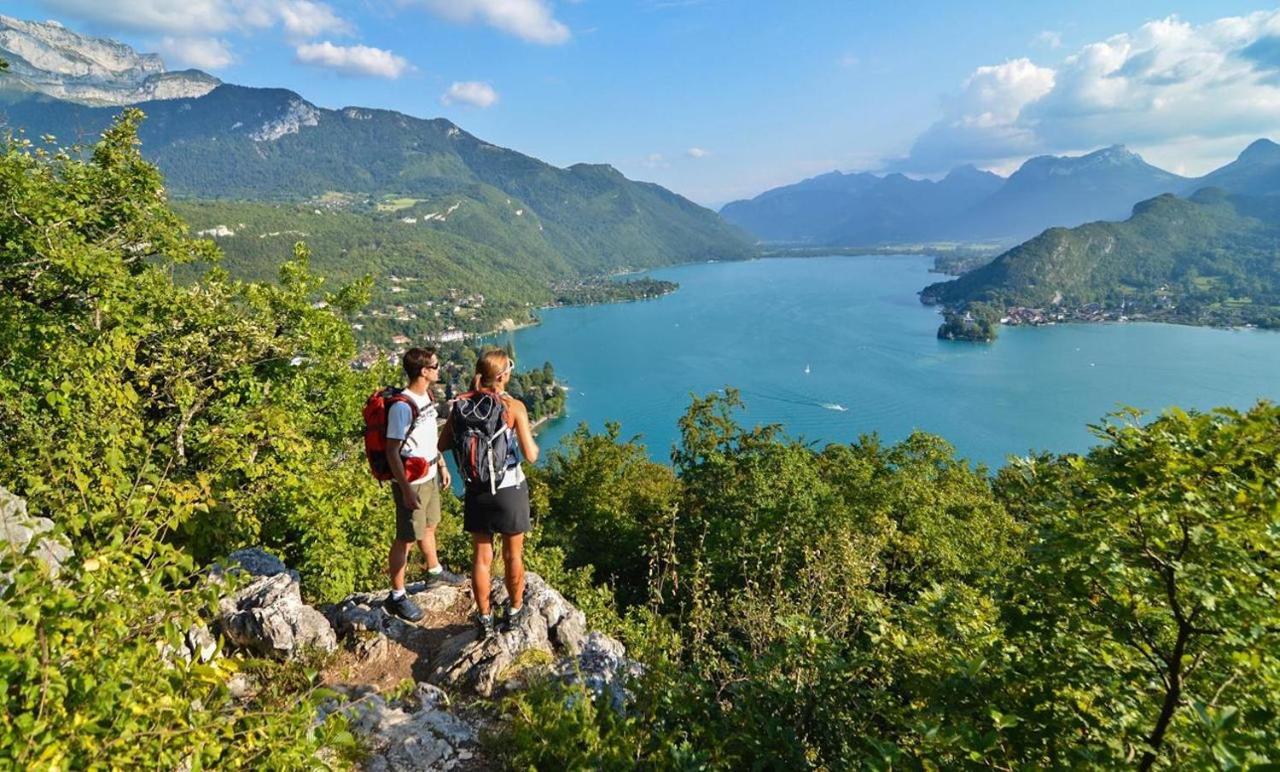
[{"left": 0, "top": 111, "right": 378, "bottom": 768}]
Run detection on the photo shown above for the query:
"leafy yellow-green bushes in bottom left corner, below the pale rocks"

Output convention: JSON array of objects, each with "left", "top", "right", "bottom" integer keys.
[{"left": 0, "top": 535, "right": 355, "bottom": 769}]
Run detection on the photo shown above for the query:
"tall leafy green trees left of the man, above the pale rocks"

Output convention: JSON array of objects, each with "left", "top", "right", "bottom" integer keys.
[{"left": 0, "top": 113, "right": 389, "bottom": 598}]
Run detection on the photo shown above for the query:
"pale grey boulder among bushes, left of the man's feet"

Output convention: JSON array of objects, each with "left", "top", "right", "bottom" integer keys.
[{"left": 214, "top": 548, "right": 338, "bottom": 659}]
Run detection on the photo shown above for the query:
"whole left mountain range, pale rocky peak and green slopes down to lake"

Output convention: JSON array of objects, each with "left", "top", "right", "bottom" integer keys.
[{"left": 0, "top": 18, "right": 755, "bottom": 302}]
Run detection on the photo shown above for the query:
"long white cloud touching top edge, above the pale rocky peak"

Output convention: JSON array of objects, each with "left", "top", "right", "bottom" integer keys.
[{"left": 44, "top": 0, "right": 353, "bottom": 38}]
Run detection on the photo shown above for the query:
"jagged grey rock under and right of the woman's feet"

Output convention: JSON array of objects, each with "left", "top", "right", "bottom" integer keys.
[{"left": 430, "top": 574, "right": 591, "bottom": 696}]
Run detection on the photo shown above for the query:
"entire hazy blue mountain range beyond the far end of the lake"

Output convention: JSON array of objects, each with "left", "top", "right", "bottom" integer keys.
[{"left": 721, "top": 146, "right": 1188, "bottom": 246}]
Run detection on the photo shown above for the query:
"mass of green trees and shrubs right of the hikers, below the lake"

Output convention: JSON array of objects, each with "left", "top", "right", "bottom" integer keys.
[{"left": 503, "top": 389, "right": 1280, "bottom": 768}]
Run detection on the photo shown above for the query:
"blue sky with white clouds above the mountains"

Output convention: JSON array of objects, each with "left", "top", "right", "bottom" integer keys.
[{"left": 0, "top": 0, "right": 1280, "bottom": 205}]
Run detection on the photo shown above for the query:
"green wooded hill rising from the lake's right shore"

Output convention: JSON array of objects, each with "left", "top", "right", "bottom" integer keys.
[{"left": 920, "top": 188, "right": 1280, "bottom": 326}]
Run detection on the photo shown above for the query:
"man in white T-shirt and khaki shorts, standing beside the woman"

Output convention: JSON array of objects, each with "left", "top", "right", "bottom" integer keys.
[{"left": 383, "top": 348, "right": 466, "bottom": 622}]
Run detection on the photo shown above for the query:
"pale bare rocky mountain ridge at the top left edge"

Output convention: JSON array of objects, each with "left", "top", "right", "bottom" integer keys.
[{"left": 0, "top": 15, "right": 219, "bottom": 105}]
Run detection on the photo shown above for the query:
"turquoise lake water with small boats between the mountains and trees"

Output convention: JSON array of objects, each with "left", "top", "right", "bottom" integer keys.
[{"left": 494, "top": 256, "right": 1280, "bottom": 466}]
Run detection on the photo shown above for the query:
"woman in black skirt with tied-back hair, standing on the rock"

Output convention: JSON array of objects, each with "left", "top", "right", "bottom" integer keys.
[{"left": 439, "top": 350, "right": 538, "bottom": 636}]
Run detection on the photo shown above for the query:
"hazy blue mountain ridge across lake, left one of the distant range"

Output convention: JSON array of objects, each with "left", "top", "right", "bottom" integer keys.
[{"left": 721, "top": 166, "right": 1004, "bottom": 246}]
